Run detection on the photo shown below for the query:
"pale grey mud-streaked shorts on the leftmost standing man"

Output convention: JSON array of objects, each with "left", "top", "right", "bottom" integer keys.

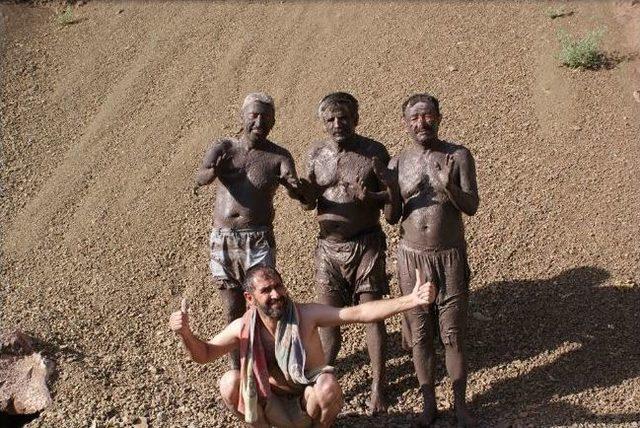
[{"left": 209, "top": 227, "right": 276, "bottom": 289}]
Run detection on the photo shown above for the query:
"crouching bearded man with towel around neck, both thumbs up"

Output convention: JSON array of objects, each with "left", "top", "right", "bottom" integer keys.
[{"left": 169, "top": 265, "right": 436, "bottom": 427}]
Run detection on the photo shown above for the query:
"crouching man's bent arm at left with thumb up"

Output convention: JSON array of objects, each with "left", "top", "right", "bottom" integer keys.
[{"left": 169, "top": 299, "right": 242, "bottom": 364}]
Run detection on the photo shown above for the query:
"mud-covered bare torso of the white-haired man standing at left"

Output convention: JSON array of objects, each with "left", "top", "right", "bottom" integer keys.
[{"left": 213, "top": 140, "right": 288, "bottom": 228}]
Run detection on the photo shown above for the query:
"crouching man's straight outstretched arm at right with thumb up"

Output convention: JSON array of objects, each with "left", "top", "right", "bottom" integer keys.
[{"left": 307, "top": 272, "right": 436, "bottom": 327}]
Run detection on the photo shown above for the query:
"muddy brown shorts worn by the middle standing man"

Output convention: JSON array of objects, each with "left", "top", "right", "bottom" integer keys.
[{"left": 316, "top": 228, "right": 389, "bottom": 305}]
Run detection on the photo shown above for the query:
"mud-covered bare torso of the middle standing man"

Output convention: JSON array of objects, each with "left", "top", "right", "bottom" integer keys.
[{"left": 310, "top": 136, "right": 389, "bottom": 241}]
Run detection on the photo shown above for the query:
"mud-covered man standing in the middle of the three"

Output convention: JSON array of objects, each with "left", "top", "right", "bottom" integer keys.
[{"left": 305, "top": 92, "right": 400, "bottom": 413}]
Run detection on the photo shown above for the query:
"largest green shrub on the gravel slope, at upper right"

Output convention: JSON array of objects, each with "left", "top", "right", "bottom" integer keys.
[{"left": 559, "top": 29, "right": 605, "bottom": 69}]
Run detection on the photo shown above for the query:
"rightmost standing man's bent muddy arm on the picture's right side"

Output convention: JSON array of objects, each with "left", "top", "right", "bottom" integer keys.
[{"left": 445, "top": 149, "right": 480, "bottom": 216}]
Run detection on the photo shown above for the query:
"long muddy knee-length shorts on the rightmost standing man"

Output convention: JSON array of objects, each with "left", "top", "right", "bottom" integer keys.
[{"left": 398, "top": 240, "right": 470, "bottom": 346}]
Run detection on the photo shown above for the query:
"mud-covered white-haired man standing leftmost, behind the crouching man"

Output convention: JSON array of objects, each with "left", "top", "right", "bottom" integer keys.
[{"left": 194, "top": 93, "right": 301, "bottom": 368}]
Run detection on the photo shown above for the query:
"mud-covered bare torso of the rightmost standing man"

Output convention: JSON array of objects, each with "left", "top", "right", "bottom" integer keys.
[{"left": 397, "top": 142, "right": 465, "bottom": 249}]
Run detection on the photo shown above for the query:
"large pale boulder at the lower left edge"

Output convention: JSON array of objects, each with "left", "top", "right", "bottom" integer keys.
[{"left": 0, "top": 330, "right": 53, "bottom": 415}]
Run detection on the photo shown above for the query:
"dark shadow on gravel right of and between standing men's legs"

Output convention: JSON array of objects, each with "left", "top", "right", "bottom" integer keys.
[{"left": 330, "top": 266, "right": 640, "bottom": 427}]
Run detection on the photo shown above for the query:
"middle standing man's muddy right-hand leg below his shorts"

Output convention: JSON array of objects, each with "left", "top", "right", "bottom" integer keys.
[{"left": 359, "top": 293, "right": 387, "bottom": 414}]
